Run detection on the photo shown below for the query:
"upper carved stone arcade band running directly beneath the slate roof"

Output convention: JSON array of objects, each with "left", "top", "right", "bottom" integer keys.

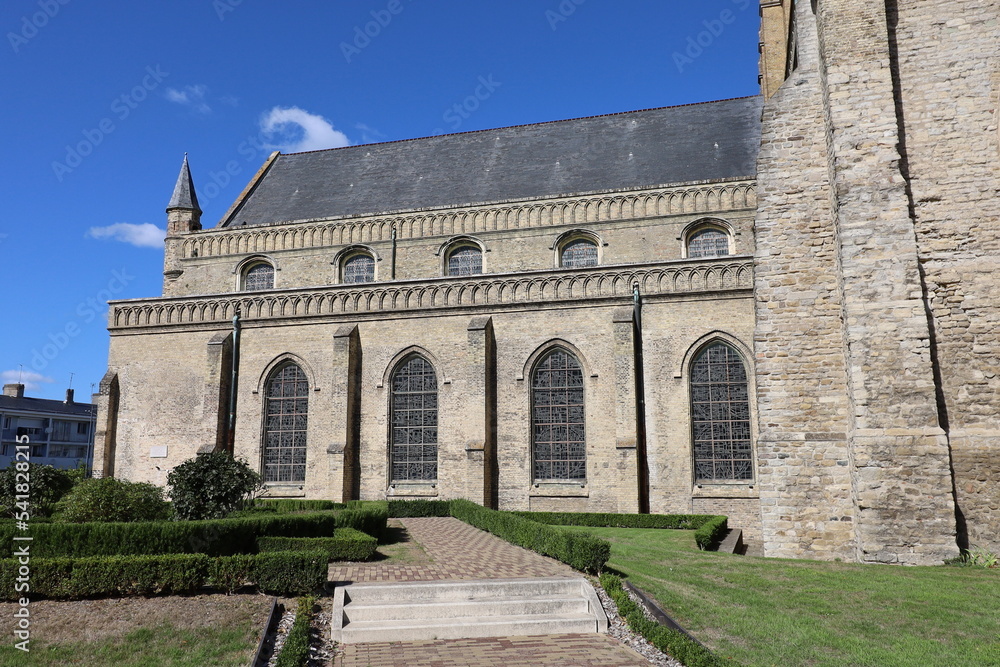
[{"left": 182, "top": 180, "right": 757, "bottom": 258}]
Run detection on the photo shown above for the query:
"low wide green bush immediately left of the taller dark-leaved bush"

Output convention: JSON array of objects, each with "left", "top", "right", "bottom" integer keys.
[{"left": 57, "top": 477, "right": 171, "bottom": 523}]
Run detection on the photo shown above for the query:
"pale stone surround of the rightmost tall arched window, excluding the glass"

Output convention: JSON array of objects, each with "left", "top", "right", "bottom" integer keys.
[{"left": 674, "top": 330, "right": 759, "bottom": 488}]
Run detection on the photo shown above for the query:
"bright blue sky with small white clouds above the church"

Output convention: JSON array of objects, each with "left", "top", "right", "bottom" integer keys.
[{"left": 0, "top": 0, "right": 759, "bottom": 398}]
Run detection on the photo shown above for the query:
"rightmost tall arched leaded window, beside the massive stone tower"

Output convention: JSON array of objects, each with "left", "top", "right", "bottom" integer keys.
[{"left": 691, "top": 343, "right": 753, "bottom": 481}]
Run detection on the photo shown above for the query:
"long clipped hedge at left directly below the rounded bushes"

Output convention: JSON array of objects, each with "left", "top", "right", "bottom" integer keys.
[{"left": 0, "top": 508, "right": 388, "bottom": 558}]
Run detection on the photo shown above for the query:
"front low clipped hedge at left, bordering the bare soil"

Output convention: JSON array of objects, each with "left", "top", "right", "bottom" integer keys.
[{"left": 0, "top": 551, "right": 327, "bottom": 600}]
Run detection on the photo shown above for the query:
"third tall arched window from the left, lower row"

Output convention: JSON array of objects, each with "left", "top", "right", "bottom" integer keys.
[{"left": 531, "top": 348, "right": 587, "bottom": 482}]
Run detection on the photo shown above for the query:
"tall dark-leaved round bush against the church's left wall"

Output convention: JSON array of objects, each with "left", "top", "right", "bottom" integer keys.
[{"left": 167, "top": 452, "right": 261, "bottom": 520}]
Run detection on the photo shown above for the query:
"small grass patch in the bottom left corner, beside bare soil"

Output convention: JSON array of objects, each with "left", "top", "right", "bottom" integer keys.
[{"left": 0, "top": 625, "right": 256, "bottom": 667}]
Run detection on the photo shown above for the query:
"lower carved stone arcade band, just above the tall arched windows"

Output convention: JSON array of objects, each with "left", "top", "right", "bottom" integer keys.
[{"left": 108, "top": 255, "right": 753, "bottom": 333}]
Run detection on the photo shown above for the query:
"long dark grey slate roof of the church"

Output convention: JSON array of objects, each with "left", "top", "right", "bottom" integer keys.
[{"left": 221, "top": 96, "right": 762, "bottom": 227}]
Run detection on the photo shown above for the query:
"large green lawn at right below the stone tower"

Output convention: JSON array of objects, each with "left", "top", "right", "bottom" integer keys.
[{"left": 565, "top": 527, "right": 1000, "bottom": 667}]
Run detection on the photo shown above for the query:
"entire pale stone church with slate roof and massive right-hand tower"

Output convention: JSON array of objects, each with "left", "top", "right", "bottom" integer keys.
[{"left": 94, "top": 0, "right": 1000, "bottom": 564}]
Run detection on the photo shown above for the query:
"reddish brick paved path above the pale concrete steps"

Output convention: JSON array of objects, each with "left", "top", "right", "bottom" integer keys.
[{"left": 330, "top": 517, "right": 581, "bottom": 583}]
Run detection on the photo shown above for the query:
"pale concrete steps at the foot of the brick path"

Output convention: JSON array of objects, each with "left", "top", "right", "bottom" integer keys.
[{"left": 331, "top": 578, "right": 608, "bottom": 643}]
